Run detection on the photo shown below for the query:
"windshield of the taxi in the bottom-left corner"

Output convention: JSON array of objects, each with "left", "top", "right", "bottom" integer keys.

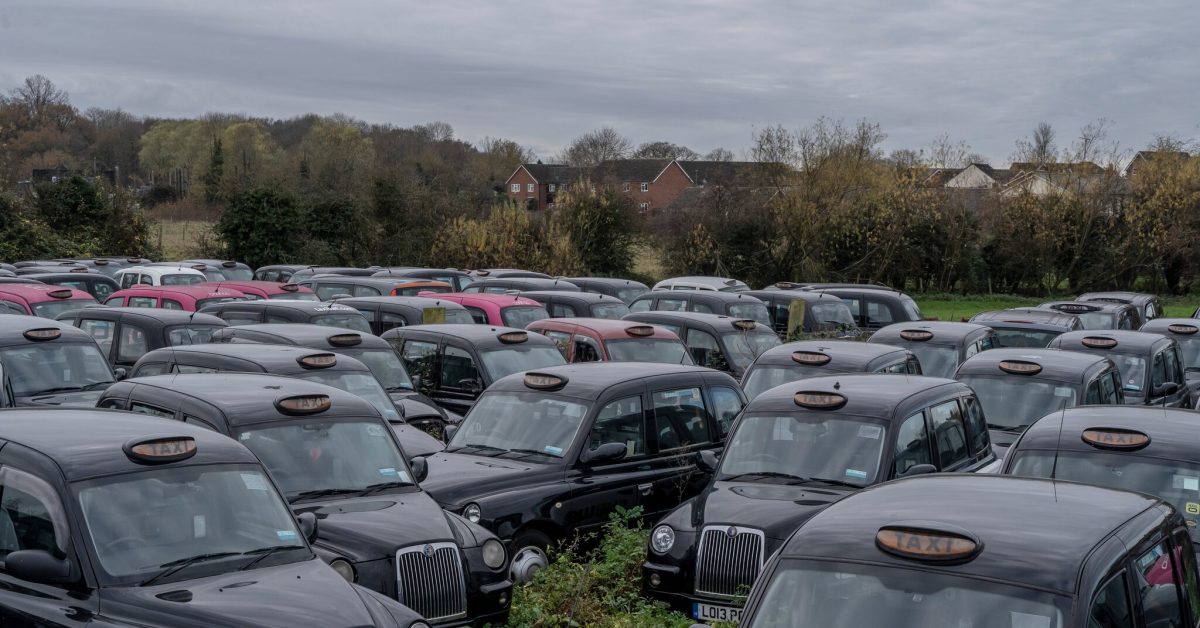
[{"left": 76, "top": 465, "right": 311, "bottom": 585}]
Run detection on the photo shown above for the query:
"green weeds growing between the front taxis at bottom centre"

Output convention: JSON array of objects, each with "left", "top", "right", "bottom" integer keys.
[{"left": 509, "top": 508, "right": 694, "bottom": 628}]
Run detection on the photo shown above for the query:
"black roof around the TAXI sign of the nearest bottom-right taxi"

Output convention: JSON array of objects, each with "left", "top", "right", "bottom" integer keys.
[{"left": 780, "top": 473, "right": 1163, "bottom": 593}]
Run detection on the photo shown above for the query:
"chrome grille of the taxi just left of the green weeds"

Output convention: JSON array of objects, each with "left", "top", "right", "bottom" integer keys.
[{"left": 396, "top": 543, "right": 467, "bottom": 621}]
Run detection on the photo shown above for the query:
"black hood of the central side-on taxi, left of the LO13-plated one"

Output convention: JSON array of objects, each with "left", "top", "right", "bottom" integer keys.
[{"left": 421, "top": 451, "right": 563, "bottom": 508}]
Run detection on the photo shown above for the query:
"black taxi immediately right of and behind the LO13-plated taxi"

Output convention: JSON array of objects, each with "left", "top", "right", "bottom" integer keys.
[{"left": 954, "top": 348, "right": 1124, "bottom": 453}]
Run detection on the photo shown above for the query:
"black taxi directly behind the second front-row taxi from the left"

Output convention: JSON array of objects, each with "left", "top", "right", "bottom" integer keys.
[{"left": 130, "top": 342, "right": 443, "bottom": 459}]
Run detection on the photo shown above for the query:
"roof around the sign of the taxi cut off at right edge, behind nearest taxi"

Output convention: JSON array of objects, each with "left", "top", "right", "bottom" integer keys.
[{"left": 1014, "top": 406, "right": 1200, "bottom": 462}]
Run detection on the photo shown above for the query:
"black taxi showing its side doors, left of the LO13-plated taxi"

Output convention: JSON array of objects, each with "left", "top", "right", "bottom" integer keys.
[{"left": 422, "top": 363, "right": 745, "bottom": 582}]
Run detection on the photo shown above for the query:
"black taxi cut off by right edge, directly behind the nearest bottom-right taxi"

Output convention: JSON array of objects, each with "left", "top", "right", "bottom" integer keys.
[{"left": 1001, "top": 406, "right": 1200, "bottom": 545}]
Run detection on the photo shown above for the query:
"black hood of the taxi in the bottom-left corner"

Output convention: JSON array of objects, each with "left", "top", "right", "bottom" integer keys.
[{"left": 100, "top": 557, "right": 393, "bottom": 628}]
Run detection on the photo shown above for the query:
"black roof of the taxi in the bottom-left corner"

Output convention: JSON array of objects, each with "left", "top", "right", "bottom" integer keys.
[{"left": 0, "top": 407, "right": 259, "bottom": 482}]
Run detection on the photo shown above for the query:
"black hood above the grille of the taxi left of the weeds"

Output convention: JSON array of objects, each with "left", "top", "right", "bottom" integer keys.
[{"left": 293, "top": 491, "right": 456, "bottom": 562}]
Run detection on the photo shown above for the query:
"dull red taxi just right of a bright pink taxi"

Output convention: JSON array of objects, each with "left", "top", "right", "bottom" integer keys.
[{"left": 526, "top": 318, "right": 695, "bottom": 364}]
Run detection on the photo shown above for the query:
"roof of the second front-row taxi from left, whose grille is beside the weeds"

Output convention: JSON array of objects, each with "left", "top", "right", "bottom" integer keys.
[{"left": 114, "top": 372, "right": 379, "bottom": 425}]
